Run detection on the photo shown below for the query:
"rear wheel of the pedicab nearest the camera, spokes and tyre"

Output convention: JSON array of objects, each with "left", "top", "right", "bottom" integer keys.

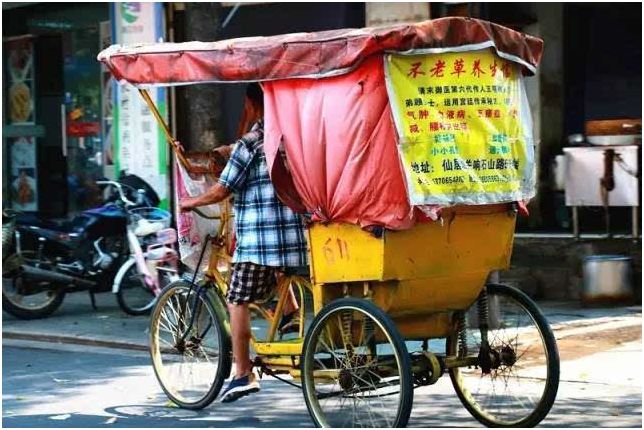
[{"left": 301, "top": 298, "right": 414, "bottom": 427}]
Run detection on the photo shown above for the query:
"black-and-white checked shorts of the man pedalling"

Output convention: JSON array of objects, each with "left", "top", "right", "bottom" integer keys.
[{"left": 226, "top": 263, "right": 278, "bottom": 305}]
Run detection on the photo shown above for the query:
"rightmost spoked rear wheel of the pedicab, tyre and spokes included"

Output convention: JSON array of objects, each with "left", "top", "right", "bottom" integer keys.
[{"left": 447, "top": 284, "right": 559, "bottom": 427}]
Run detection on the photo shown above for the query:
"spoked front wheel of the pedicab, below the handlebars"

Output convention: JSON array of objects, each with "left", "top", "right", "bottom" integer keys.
[{"left": 150, "top": 280, "right": 232, "bottom": 410}]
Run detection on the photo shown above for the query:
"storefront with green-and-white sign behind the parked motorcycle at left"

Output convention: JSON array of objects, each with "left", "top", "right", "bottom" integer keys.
[{"left": 2, "top": 3, "right": 168, "bottom": 216}]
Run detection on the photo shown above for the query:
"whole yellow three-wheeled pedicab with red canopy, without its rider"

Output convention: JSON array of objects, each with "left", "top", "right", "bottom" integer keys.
[{"left": 98, "top": 18, "right": 559, "bottom": 427}]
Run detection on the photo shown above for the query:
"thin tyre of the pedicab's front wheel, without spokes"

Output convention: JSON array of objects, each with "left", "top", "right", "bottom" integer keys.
[{"left": 150, "top": 279, "right": 233, "bottom": 410}]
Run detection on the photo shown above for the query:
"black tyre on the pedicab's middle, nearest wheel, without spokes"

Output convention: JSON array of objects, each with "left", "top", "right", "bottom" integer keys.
[{"left": 300, "top": 298, "right": 414, "bottom": 427}]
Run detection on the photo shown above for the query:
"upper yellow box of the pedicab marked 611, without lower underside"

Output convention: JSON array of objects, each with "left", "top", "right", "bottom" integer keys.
[{"left": 309, "top": 205, "right": 516, "bottom": 284}]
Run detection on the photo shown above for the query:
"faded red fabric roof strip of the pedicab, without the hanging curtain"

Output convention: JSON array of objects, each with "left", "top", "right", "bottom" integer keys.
[{"left": 98, "top": 17, "right": 543, "bottom": 86}]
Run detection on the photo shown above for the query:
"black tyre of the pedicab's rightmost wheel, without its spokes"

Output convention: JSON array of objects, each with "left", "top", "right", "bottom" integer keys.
[{"left": 446, "top": 284, "right": 559, "bottom": 427}]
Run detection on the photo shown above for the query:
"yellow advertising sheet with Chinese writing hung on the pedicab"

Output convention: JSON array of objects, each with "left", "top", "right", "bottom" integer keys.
[{"left": 385, "top": 49, "right": 534, "bottom": 205}]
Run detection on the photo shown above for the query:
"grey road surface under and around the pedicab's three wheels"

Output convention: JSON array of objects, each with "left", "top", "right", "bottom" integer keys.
[{"left": 2, "top": 340, "right": 642, "bottom": 428}]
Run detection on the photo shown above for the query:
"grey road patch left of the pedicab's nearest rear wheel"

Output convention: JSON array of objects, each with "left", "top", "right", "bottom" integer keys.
[{"left": 2, "top": 348, "right": 312, "bottom": 428}]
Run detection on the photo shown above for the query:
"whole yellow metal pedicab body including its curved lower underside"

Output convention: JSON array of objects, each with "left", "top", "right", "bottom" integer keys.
[{"left": 309, "top": 205, "right": 516, "bottom": 339}]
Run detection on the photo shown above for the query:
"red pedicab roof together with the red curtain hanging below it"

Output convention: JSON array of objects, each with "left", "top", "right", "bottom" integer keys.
[{"left": 98, "top": 17, "right": 543, "bottom": 229}]
